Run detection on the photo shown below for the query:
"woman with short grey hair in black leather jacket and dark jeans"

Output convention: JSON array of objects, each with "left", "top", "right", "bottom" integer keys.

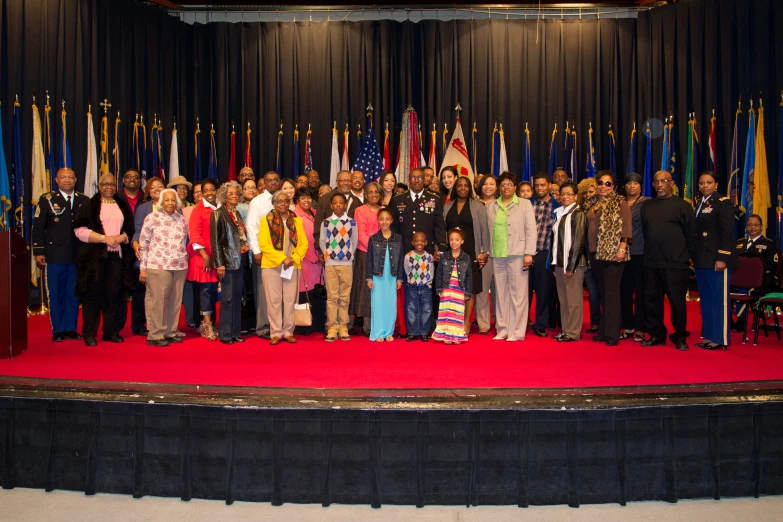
[{"left": 209, "top": 181, "right": 250, "bottom": 344}]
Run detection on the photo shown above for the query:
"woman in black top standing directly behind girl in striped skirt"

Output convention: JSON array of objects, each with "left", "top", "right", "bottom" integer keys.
[{"left": 443, "top": 176, "right": 489, "bottom": 335}]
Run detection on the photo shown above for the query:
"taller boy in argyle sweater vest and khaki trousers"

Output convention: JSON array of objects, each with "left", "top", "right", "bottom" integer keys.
[{"left": 319, "top": 193, "right": 358, "bottom": 342}]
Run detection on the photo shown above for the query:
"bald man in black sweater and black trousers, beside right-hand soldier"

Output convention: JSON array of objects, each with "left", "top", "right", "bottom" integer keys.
[{"left": 641, "top": 170, "right": 696, "bottom": 351}]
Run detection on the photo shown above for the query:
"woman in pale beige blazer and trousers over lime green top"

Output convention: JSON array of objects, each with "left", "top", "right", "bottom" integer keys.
[{"left": 487, "top": 172, "right": 537, "bottom": 341}]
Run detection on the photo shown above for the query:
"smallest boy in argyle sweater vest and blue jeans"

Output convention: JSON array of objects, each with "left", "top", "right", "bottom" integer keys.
[{"left": 404, "top": 232, "right": 435, "bottom": 343}]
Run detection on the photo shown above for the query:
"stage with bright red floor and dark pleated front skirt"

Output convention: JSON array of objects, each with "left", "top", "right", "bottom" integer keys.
[{"left": 0, "top": 302, "right": 783, "bottom": 507}]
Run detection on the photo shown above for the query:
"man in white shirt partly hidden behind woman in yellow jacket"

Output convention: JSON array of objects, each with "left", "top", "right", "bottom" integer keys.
[{"left": 245, "top": 170, "right": 280, "bottom": 340}]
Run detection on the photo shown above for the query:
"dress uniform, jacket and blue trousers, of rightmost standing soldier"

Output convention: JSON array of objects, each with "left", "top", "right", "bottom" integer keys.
[{"left": 693, "top": 193, "right": 739, "bottom": 348}]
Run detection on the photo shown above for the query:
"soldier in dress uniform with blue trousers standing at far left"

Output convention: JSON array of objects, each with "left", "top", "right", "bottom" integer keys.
[{"left": 32, "top": 168, "right": 89, "bottom": 342}]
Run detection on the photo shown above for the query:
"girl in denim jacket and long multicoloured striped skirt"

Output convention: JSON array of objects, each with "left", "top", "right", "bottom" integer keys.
[{"left": 432, "top": 228, "right": 473, "bottom": 344}]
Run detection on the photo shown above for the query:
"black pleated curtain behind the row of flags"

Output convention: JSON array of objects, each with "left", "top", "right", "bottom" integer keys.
[{"left": 0, "top": 0, "right": 783, "bottom": 225}]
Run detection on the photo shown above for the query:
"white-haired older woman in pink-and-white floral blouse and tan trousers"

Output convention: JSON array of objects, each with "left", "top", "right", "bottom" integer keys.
[{"left": 138, "top": 188, "right": 188, "bottom": 347}]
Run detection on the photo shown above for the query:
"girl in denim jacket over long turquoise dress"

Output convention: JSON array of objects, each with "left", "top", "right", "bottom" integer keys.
[{"left": 365, "top": 208, "right": 403, "bottom": 343}]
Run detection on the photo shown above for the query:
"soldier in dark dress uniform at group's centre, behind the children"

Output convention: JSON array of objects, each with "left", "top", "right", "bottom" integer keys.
[{"left": 390, "top": 169, "right": 448, "bottom": 255}]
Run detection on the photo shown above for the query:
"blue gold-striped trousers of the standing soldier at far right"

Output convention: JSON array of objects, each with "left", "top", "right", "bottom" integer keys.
[{"left": 696, "top": 268, "right": 733, "bottom": 346}]
